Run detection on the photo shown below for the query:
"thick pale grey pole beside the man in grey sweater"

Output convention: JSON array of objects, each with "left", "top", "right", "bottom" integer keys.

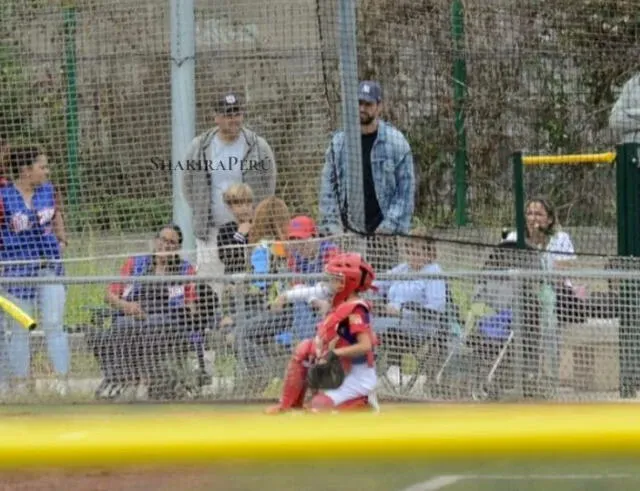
[{"left": 170, "top": 0, "right": 196, "bottom": 260}]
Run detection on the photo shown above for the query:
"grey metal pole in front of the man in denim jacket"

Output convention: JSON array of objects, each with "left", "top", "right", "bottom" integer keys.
[{"left": 338, "top": 0, "right": 362, "bottom": 232}]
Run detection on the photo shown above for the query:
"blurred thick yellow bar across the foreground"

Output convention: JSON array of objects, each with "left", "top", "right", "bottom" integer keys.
[{"left": 0, "top": 404, "right": 640, "bottom": 469}]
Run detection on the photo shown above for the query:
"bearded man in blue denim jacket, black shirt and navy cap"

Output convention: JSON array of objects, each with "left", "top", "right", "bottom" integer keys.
[{"left": 319, "top": 81, "right": 415, "bottom": 270}]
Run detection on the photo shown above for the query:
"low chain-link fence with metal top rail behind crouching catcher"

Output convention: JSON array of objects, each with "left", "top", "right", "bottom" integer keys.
[{"left": 0, "top": 239, "right": 640, "bottom": 403}]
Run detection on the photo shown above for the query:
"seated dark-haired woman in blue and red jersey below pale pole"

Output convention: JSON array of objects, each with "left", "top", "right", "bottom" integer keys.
[{"left": 92, "top": 225, "right": 205, "bottom": 397}]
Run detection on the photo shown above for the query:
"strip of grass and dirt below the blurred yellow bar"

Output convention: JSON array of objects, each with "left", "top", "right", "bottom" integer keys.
[{"left": 0, "top": 462, "right": 640, "bottom": 491}]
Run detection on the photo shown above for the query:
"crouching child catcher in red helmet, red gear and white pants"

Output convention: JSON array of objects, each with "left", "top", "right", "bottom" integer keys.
[{"left": 267, "top": 253, "right": 378, "bottom": 414}]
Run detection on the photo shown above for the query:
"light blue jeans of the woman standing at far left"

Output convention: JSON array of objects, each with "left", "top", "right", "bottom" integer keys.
[{"left": 0, "top": 271, "right": 69, "bottom": 378}]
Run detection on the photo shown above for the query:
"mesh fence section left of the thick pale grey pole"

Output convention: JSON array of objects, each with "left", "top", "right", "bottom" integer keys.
[{"left": 1, "top": 1, "right": 171, "bottom": 233}]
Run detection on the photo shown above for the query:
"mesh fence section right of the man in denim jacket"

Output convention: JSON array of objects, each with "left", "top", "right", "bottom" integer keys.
[{"left": 324, "top": 0, "right": 637, "bottom": 238}]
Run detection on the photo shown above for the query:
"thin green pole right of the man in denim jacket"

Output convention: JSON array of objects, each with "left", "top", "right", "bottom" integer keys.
[{"left": 451, "top": 0, "right": 468, "bottom": 226}]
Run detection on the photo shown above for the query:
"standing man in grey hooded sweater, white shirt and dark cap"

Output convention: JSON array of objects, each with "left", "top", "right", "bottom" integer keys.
[{"left": 183, "top": 93, "right": 277, "bottom": 284}]
